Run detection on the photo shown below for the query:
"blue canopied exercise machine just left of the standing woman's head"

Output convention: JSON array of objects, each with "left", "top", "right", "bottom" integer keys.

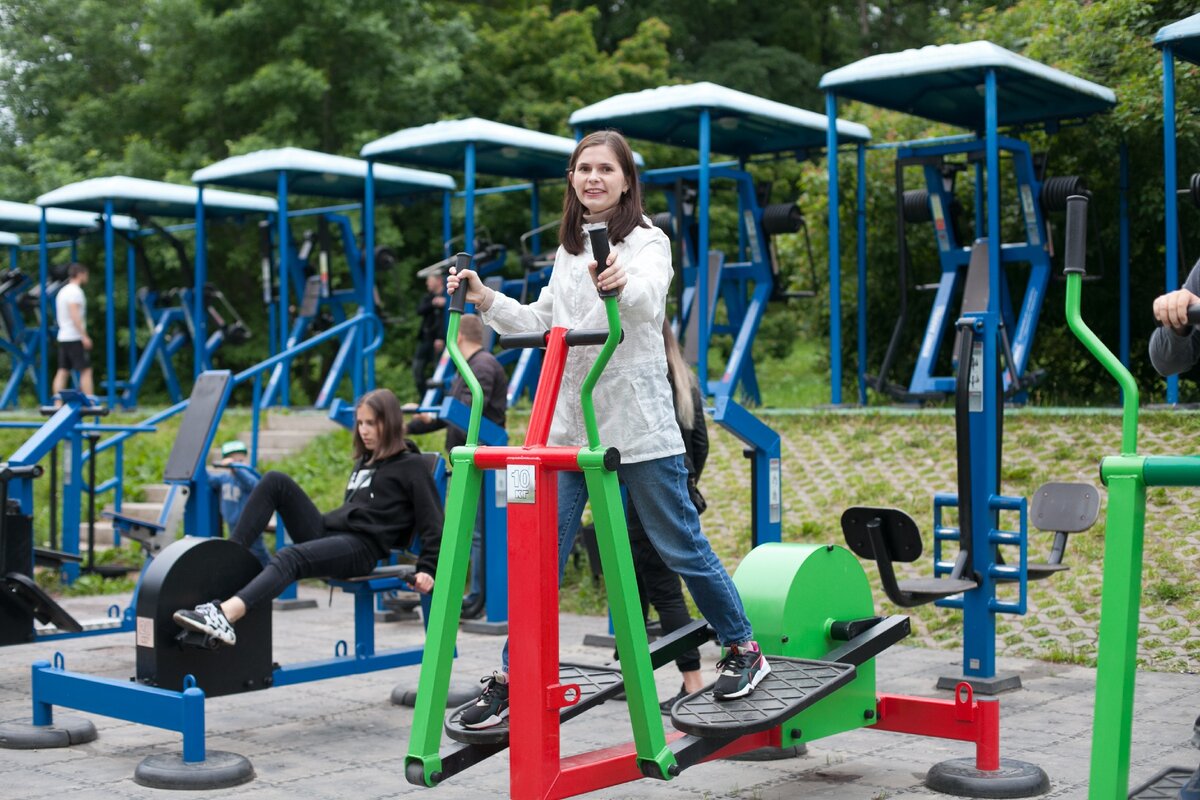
[{"left": 360, "top": 118, "right": 575, "bottom": 633}]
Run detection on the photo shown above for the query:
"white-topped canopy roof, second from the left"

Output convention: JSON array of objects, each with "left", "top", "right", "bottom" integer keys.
[{"left": 35, "top": 175, "right": 278, "bottom": 217}]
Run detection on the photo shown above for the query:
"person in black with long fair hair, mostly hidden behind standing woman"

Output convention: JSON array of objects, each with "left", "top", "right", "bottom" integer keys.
[{"left": 625, "top": 321, "right": 708, "bottom": 714}]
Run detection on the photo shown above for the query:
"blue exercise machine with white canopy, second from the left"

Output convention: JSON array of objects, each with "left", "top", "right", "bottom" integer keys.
[{"left": 36, "top": 176, "right": 276, "bottom": 408}]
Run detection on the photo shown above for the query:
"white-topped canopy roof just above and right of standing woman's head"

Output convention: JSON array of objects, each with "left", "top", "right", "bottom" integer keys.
[{"left": 570, "top": 82, "right": 871, "bottom": 152}]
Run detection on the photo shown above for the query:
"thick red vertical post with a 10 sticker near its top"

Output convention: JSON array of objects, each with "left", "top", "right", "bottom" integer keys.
[{"left": 508, "top": 456, "right": 559, "bottom": 800}]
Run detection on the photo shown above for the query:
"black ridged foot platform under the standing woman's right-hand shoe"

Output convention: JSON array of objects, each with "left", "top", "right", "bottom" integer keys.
[{"left": 671, "top": 656, "right": 856, "bottom": 738}]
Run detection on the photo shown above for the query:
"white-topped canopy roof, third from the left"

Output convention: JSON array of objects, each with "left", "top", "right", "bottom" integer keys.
[{"left": 192, "top": 148, "right": 455, "bottom": 197}]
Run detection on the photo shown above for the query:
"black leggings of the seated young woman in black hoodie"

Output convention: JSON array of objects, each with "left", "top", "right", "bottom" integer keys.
[{"left": 229, "top": 471, "right": 385, "bottom": 609}]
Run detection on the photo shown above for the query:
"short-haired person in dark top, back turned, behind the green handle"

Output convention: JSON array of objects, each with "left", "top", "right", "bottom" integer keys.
[{"left": 408, "top": 314, "right": 509, "bottom": 616}]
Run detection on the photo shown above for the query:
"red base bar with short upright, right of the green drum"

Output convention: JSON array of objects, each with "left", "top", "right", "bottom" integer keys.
[{"left": 871, "top": 684, "right": 1000, "bottom": 772}]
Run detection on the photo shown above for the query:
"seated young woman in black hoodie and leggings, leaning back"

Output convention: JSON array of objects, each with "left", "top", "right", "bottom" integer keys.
[{"left": 174, "top": 389, "right": 443, "bottom": 645}]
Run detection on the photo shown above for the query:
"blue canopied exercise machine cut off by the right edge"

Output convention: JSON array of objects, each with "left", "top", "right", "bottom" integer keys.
[{"left": 1152, "top": 14, "right": 1200, "bottom": 405}]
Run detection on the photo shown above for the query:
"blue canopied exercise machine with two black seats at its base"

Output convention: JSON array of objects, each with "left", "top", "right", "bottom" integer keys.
[{"left": 821, "top": 42, "right": 1116, "bottom": 693}]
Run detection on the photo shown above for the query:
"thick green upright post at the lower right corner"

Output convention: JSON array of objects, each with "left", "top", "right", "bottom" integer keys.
[{"left": 1087, "top": 457, "right": 1146, "bottom": 800}]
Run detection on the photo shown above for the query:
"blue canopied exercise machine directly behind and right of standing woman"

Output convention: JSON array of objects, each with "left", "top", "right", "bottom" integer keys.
[{"left": 570, "top": 83, "right": 870, "bottom": 546}]
